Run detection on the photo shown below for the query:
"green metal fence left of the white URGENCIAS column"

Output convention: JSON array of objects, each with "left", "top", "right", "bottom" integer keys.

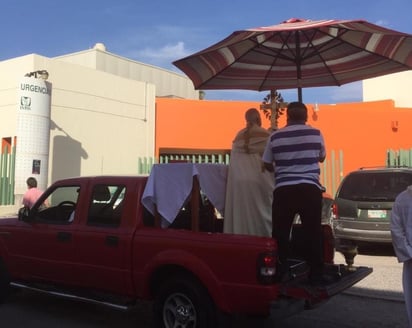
[{"left": 0, "top": 146, "right": 16, "bottom": 205}]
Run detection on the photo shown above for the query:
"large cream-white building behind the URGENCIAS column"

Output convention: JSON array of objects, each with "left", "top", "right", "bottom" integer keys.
[{"left": 0, "top": 43, "right": 199, "bottom": 204}]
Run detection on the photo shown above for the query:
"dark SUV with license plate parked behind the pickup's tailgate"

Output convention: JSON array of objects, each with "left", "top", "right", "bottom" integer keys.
[{"left": 332, "top": 167, "right": 412, "bottom": 246}]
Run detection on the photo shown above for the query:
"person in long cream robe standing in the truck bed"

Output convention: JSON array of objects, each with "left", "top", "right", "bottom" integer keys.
[{"left": 224, "top": 108, "right": 274, "bottom": 237}]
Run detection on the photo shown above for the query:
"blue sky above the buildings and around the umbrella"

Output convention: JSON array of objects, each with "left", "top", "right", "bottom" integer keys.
[{"left": 0, "top": 0, "right": 412, "bottom": 103}]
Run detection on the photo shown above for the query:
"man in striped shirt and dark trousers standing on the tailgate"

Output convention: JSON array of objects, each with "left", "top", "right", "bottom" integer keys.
[{"left": 263, "top": 102, "right": 326, "bottom": 283}]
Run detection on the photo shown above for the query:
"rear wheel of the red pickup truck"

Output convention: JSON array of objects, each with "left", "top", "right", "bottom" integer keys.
[{"left": 154, "top": 277, "right": 217, "bottom": 328}]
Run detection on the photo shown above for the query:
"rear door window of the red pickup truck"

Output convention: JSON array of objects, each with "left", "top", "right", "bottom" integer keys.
[{"left": 87, "top": 184, "right": 126, "bottom": 226}]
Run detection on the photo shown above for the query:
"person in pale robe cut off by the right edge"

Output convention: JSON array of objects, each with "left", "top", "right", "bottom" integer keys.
[{"left": 391, "top": 186, "right": 412, "bottom": 328}]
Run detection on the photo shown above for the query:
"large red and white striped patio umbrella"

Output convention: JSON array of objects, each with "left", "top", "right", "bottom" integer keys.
[{"left": 173, "top": 18, "right": 412, "bottom": 101}]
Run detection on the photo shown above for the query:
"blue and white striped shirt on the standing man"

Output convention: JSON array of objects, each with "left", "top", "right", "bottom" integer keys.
[{"left": 262, "top": 123, "right": 326, "bottom": 189}]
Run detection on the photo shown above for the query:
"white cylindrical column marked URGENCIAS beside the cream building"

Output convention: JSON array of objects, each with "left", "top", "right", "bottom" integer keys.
[{"left": 15, "top": 77, "right": 52, "bottom": 197}]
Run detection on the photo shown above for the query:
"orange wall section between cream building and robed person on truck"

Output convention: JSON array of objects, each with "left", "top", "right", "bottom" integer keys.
[{"left": 156, "top": 98, "right": 260, "bottom": 149}]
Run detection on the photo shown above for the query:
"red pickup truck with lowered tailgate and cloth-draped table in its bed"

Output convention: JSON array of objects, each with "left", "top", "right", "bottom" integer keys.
[{"left": 0, "top": 163, "right": 372, "bottom": 327}]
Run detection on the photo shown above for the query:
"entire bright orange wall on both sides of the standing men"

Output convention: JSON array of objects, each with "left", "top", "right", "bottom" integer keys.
[{"left": 156, "top": 98, "right": 412, "bottom": 175}]
